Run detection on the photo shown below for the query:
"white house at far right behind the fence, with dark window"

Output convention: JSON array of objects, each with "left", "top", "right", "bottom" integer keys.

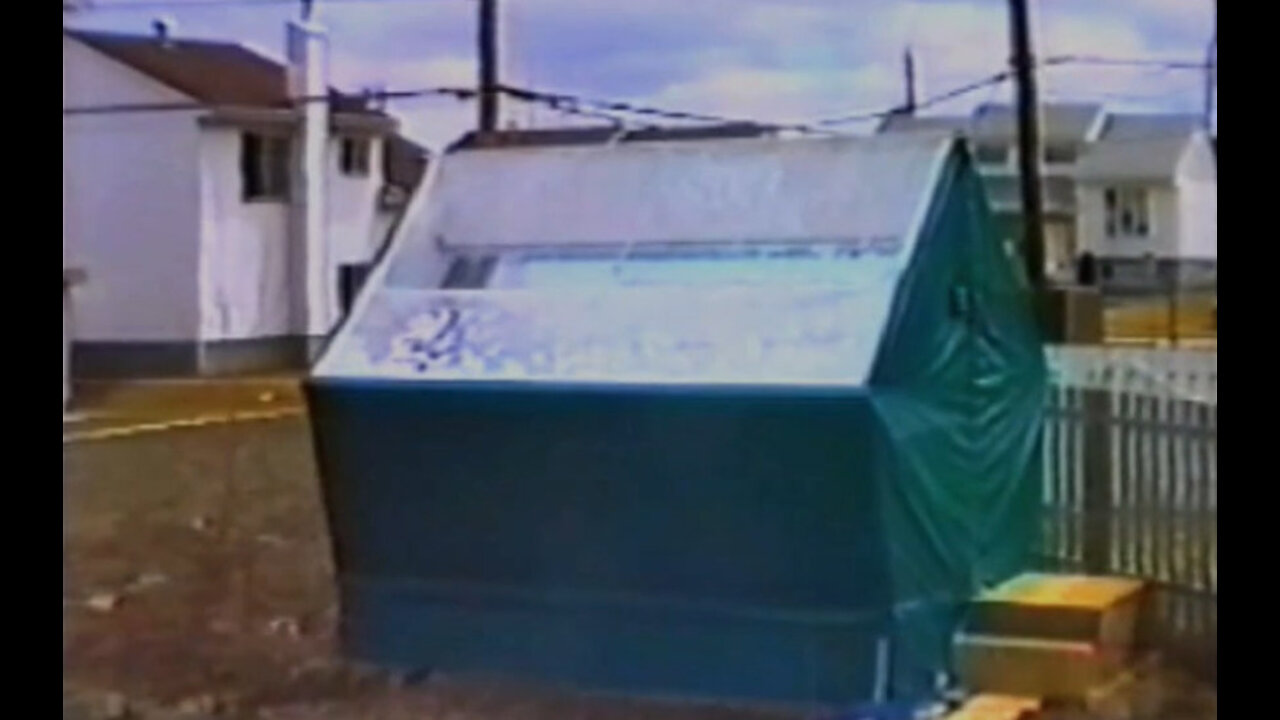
[{"left": 1076, "top": 115, "right": 1217, "bottom": 290}]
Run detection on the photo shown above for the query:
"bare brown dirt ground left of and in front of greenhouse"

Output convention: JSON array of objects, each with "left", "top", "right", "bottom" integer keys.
[{"left": 63, "top": 395, "right": 1216, "bottom": 720}]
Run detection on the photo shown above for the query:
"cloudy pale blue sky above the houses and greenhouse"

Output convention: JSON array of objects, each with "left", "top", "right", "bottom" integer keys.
[{"left": 64, "top": 0, "right": 1216, "bottom": 149}]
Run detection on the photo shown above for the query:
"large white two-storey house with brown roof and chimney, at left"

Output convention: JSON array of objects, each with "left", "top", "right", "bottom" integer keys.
[{"left": 63, "top": 23, "right": 425, "bottom": 375}]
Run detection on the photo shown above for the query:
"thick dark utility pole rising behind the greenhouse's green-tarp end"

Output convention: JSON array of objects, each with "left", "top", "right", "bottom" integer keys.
[{"left": 1009, "top": 0, "right": 1044, "bottom": 292}]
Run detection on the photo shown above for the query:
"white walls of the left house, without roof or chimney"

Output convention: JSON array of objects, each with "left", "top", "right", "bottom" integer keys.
[{"left": 63, "top": 35, "right": 404, "bottom": 379}]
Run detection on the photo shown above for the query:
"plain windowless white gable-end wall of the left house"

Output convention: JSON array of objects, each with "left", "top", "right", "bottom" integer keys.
[{"left": 63, "top": 36, "right": 200, "bottom": 343}]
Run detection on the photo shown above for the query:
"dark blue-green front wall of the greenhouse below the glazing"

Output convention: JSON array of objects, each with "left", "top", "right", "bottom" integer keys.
[{"left": 308, "top": 379, "right": 891, "bottom": 703}]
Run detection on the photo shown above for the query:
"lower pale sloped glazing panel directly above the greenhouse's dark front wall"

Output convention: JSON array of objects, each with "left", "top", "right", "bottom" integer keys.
[{"left": 320, "top": 287, "right": 892, "bottom": 386}]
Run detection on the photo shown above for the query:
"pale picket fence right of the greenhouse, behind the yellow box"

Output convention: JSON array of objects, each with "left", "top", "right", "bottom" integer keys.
[{"left": 1043, "top": 347, "right": 1217, "bottom": 669}]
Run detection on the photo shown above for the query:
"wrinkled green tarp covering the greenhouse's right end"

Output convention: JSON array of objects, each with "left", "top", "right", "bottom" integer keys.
[{"left": 870, "top": 152, "right": 1046, "bottom": 694}]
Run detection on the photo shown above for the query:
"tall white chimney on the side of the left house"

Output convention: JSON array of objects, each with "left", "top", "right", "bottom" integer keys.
[{"left": 287, "top": 18, "right": 339, "bottom": 338}]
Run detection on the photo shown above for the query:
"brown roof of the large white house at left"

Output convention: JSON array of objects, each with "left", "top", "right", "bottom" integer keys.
[{"left": 63, "top": 28, "right": 381, "bottom": 115}]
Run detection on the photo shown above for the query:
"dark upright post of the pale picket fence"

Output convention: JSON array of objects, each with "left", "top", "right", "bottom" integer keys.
[{"left": 1082, "top": 383, "right": 1114, "bottom": 574}]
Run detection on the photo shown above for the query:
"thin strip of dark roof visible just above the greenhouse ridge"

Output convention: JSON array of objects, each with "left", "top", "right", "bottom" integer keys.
[{"left": 451, "top": 123, "right": 771, "bottom": 150}]
